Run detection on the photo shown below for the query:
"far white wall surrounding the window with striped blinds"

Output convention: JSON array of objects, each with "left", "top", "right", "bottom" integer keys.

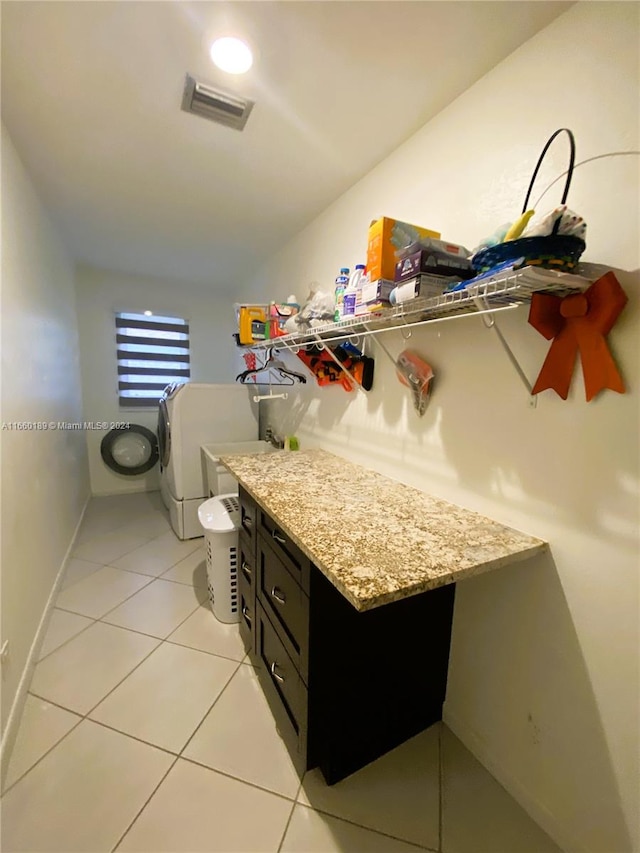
[{"left": 76, "top": 266, "right": 239, "bottom": 495}]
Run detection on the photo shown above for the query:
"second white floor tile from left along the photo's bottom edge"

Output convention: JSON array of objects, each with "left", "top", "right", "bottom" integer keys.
[{"left": 118, "top": 759, "right": 292, "bottom": 853}]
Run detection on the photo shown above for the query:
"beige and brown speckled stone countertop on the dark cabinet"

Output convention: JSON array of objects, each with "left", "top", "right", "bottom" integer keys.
[{"left": 220, "top": 450, "right": 547, "bottom": 610}]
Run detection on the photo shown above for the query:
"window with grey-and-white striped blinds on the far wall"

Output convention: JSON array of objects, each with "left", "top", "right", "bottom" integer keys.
[{"left": 116, "top": 314, "right": 191, "bottom": 408}]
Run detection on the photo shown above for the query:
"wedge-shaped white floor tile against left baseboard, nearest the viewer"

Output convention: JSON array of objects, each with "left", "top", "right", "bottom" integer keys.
[{"left": 3, "top": 695, "right": 82, "bottom": 789}]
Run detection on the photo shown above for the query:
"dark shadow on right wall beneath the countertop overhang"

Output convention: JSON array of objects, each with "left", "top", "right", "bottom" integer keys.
[{"left": 444, "top": 552, "right": 636, "bottom": 853}]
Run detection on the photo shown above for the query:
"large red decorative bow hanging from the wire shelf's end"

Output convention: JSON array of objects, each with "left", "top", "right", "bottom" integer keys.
[{"left": 529, "top": 272, "right": 627, "bottom": 401}]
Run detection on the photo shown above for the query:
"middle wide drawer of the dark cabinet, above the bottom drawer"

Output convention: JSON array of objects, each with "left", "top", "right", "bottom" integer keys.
[{"left": 257, "top": 534, "right": 309, "bottom": 681}]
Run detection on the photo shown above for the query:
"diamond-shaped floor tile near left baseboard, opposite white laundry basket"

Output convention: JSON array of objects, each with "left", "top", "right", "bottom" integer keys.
[{"left": 56, "top": 566, "right": 151, "bottom": 619}]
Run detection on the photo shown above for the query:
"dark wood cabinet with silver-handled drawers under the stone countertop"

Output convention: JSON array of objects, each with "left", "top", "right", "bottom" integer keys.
[{"left": 239, "top": 489, "right": 455, "bottom": 785}]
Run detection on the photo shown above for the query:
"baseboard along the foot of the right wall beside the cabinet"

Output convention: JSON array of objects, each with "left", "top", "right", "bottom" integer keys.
[{"left": 442, "top": 702, "right": 590, "bottom": 853}]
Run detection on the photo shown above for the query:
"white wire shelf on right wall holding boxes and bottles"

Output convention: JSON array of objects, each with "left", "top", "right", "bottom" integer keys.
[{"left": 250, "top": 264, "right": 593, "bottom": 349}]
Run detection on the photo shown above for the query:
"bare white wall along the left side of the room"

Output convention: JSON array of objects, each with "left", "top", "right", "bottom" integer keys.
[{"left": 1, "top": 126, "right": 89, "bottom": 754}]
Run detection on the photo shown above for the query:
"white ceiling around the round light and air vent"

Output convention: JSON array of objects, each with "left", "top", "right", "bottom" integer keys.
[{"left": 1, "top": 0, "right": 571, "bottom": 290}]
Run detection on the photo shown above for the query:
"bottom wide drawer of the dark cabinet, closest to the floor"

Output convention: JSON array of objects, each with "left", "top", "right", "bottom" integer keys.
[{"left": 256, "top": 601, "right": 308, "bottom": 773}]
